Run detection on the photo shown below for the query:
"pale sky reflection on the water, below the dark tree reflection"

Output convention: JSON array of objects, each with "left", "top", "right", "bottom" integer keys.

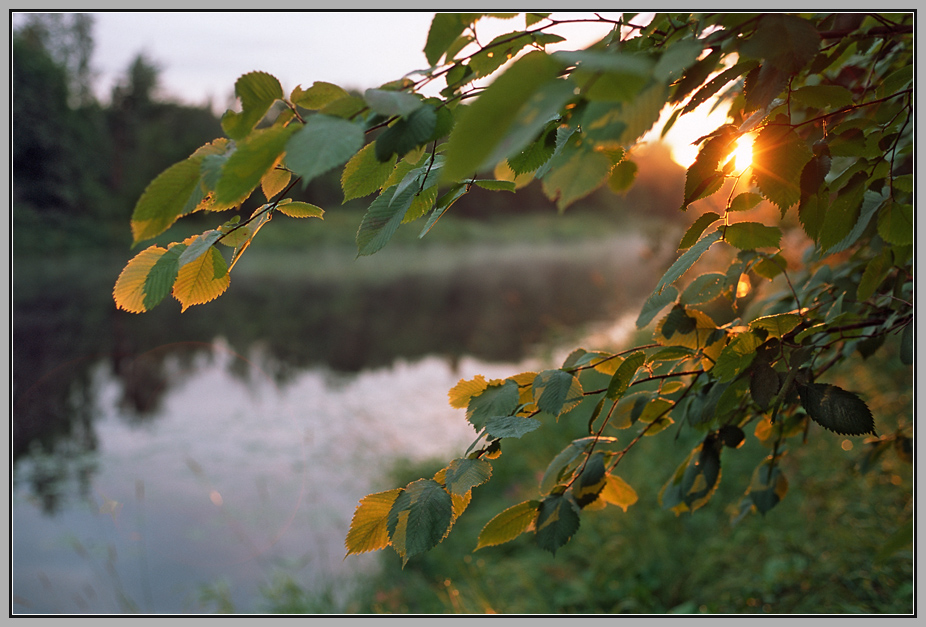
[{"left": 13, "top": 343, "right": 544, "bottom": 613}]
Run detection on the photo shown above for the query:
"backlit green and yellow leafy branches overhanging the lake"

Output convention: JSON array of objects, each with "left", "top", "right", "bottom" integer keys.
[{"left": 114, "top": 13, "right": 915, "bottom": 560}]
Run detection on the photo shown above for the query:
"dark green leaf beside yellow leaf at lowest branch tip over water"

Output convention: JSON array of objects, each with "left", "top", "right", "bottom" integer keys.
[{"left": 386, "top": 479, "right": 453, "bottom": 562}]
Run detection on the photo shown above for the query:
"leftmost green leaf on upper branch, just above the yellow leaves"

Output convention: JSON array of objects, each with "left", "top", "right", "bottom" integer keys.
[{"left": 131, "top": 156, "right": 203, "bottom": 244}]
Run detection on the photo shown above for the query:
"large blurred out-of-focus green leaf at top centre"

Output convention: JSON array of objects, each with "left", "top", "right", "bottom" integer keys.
[{"left": 444, "top": 51, "right": 560, "bottom": 182}]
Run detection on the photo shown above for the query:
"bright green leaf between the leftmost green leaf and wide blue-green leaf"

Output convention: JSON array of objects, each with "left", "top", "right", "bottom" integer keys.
[{"left": 215, "top": 126, "right": 297, "bottom": 206}]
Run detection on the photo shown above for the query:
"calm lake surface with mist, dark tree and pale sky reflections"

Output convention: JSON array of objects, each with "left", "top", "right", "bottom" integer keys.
[{"left": 11, "top": 236, "right": 668, "bottom": 613}]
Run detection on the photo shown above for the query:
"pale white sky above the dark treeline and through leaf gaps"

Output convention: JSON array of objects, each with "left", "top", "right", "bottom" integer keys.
[{"left": 14, "top": 10, "right": 723, "bottom": 165}]
